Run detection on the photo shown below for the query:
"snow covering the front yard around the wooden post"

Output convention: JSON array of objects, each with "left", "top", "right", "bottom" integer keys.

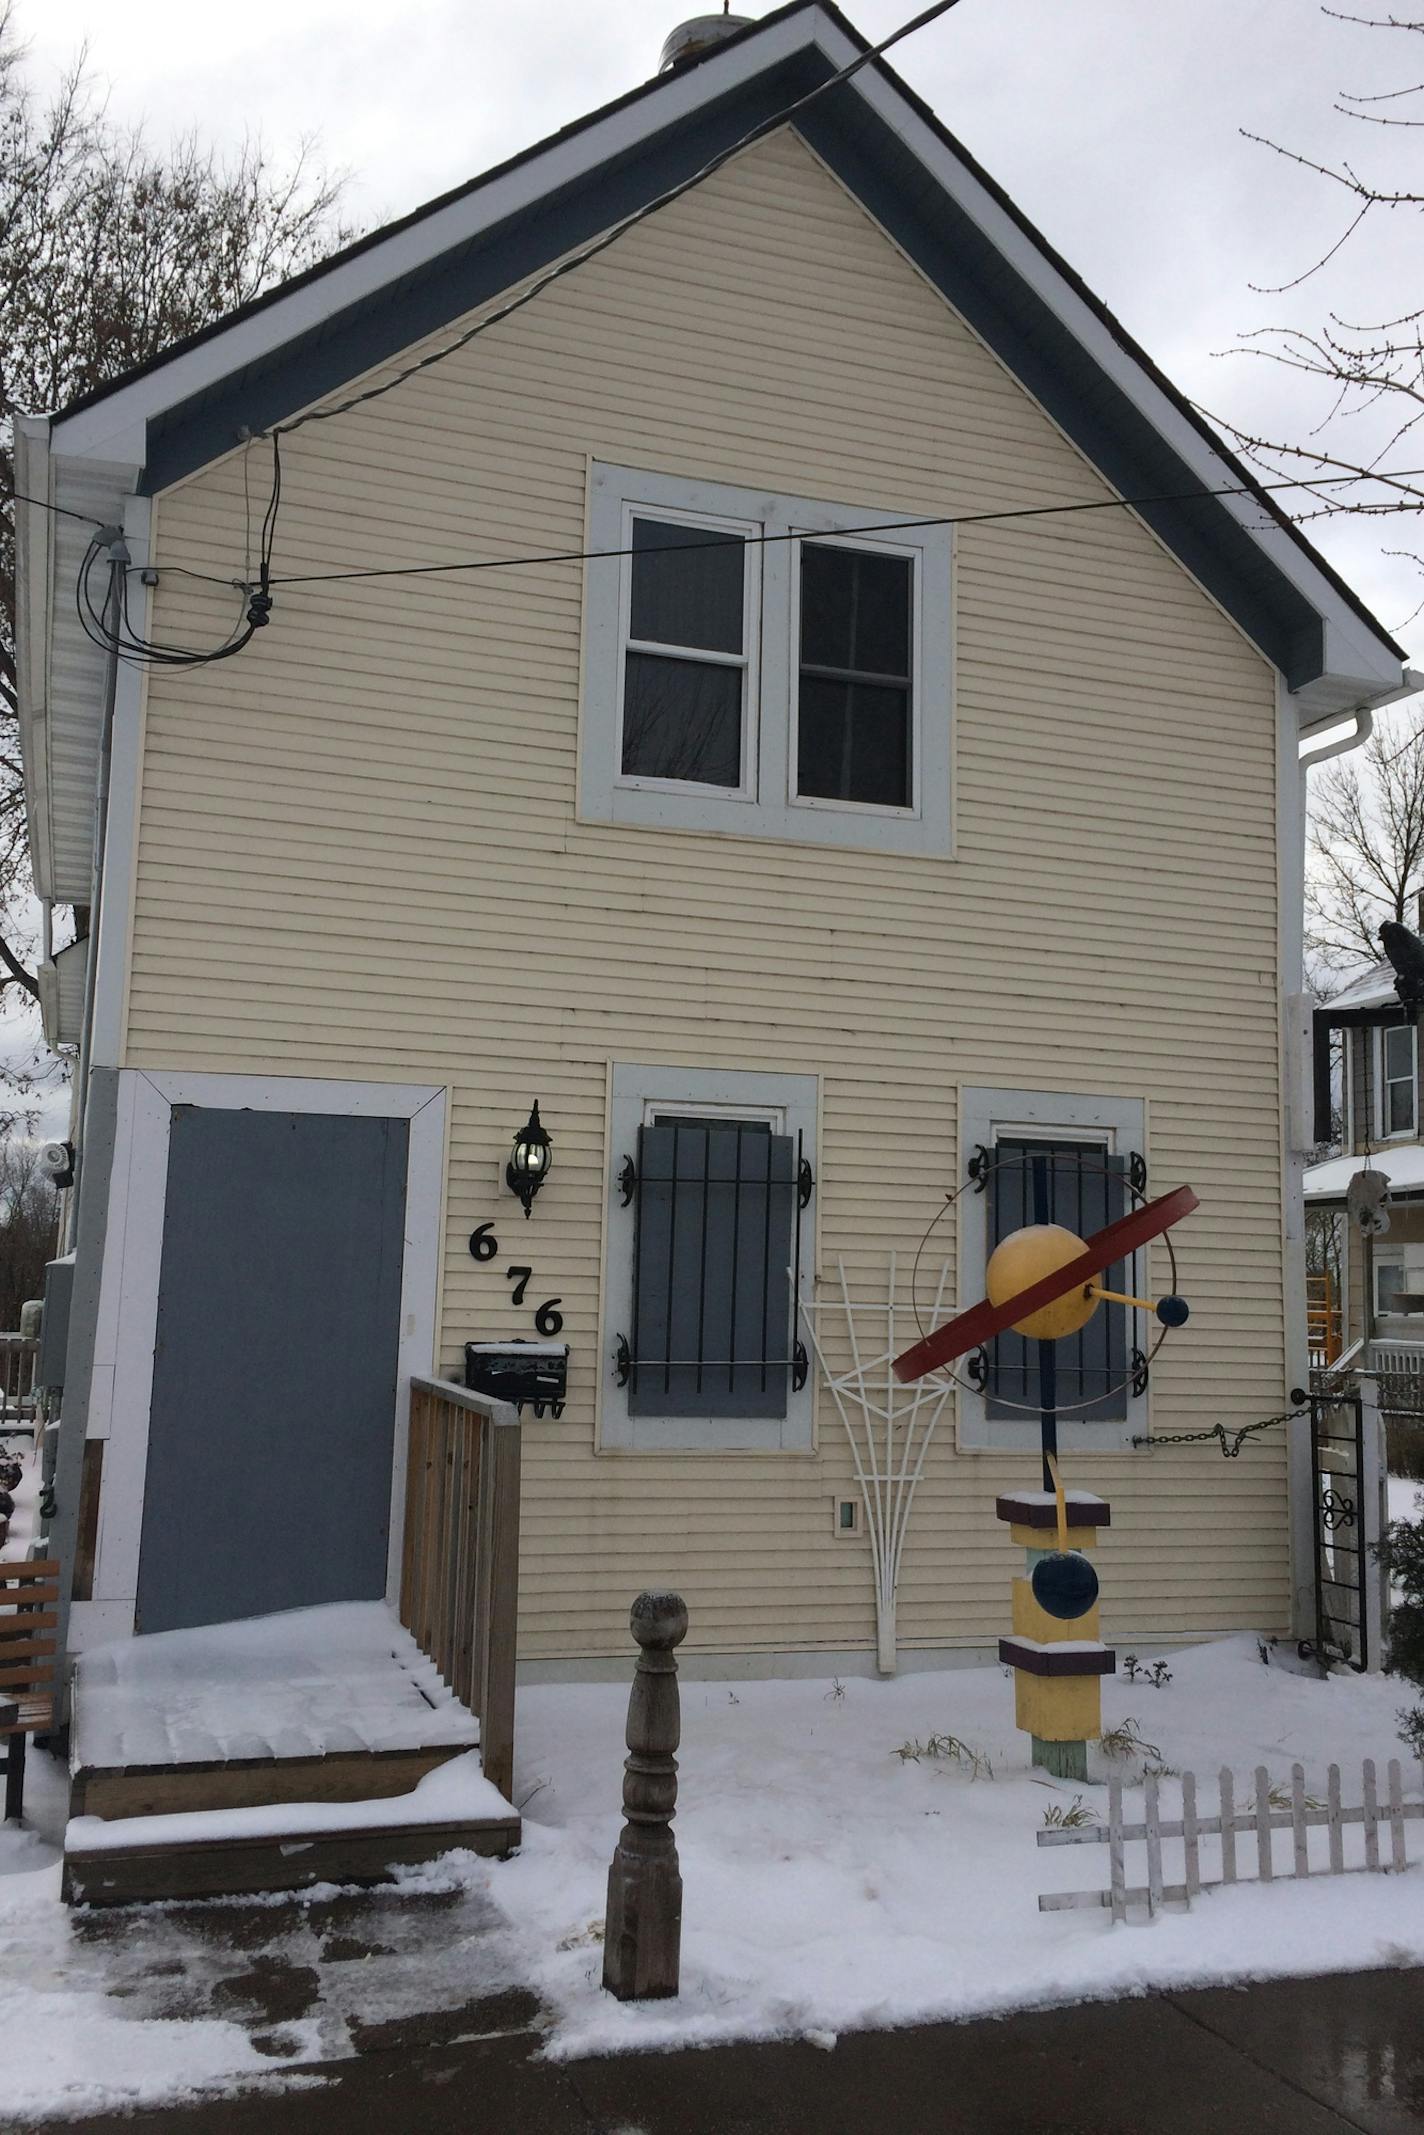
[{"left": 0, "top": 1638, "right": 1424, "bottom": 2114}]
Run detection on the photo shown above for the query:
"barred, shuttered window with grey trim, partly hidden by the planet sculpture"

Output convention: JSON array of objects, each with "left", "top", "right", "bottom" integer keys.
[{"left": 956, "top": 1089, "right": 1166, "bottom": 1452}]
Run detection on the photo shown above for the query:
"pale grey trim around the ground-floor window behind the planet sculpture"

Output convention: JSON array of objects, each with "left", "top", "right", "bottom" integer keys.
[{"left": 956, "top": 1089, "right": 1151, "bottom": 1454}]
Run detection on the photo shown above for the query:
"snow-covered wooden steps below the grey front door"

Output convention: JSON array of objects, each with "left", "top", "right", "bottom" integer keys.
[{"left": 64, "top": 1603, "right": 521, "bottom": 1904}]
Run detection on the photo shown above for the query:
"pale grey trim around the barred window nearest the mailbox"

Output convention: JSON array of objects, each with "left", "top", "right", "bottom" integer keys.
[{"left": 596, "top": 1061, "right": 820, "bottom": 1454}]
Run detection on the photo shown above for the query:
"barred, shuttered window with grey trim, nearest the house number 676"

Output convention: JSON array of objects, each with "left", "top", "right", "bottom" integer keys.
[{"left": 600, "top": 1063, "right": 816, "bottom": 1452}]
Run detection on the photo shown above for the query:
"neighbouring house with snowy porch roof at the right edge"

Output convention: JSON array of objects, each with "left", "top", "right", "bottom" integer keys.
[{"left": 1304, "top": 963, "right": 1424, "bottom": 1347}]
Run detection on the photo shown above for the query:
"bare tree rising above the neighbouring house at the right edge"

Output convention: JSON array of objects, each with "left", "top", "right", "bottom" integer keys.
[{"left": 1304, "top": 713, "right": 1424, "bottom": 991}]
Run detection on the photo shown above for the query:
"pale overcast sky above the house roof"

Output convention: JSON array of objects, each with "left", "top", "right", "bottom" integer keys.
[{"left": 17, "top": 0, "right": 1424, "bottom": 1127}]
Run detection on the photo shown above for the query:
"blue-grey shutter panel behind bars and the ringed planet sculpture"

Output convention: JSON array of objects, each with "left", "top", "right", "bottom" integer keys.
[{"left": 984, "top": 1140, "right": 1132, "bottom": 1422}]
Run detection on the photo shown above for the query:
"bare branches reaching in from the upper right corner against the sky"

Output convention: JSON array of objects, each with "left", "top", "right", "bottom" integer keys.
[{"left": 1213, "top": 6, "right": 1424, "bottom": 602}]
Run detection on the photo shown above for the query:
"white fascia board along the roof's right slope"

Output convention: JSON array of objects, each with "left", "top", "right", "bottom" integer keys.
[{"left": 818, "top": 17, "right": 1401, "bottom": 694}]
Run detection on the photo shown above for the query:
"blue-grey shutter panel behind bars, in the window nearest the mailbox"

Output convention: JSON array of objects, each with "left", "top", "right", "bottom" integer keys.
[{"left": 628, "top": 1119, "right": 796, "bottom": 1416}]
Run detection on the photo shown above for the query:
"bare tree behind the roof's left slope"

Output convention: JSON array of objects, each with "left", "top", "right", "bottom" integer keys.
[{"left": 0, "top": 0, "right": 348, "bottom": 997}]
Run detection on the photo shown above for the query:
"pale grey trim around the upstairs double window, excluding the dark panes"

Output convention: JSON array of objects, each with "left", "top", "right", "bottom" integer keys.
[{"left": 579, "top": 461, "right": 954, "bottom": 854}]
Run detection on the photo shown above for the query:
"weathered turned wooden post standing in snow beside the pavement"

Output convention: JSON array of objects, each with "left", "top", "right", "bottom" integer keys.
[{"left": 604, "top": 1593, "right": 687, "bottom": 2000}]
